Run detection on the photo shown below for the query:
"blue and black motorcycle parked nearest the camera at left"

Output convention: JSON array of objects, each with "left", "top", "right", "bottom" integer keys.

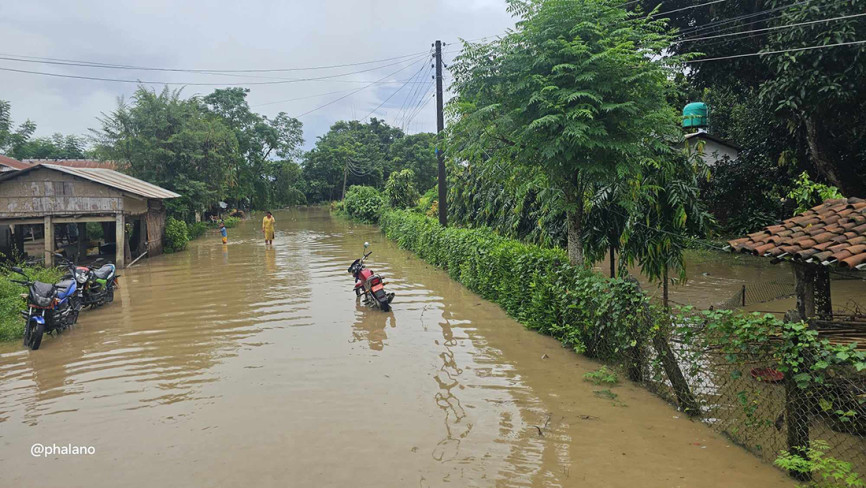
[{"left": 11, "top": 262, "right": 81, "bottom": 351}]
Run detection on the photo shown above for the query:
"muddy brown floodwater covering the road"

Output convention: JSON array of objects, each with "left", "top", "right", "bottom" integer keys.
[{"left": 0, "top": 210, "right": 791, "bottom": 488}]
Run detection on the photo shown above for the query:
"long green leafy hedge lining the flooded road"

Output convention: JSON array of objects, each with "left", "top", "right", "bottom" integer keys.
[{"left": 379, "top": 211, "right": 648, "bottom": 361}]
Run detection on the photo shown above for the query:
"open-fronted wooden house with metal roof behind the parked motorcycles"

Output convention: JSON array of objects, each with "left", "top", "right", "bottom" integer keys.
[{"left": 0, "top": 164, "right": 180, "bottom": 268}]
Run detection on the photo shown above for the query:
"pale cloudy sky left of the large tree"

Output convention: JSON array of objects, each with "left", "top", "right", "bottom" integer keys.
[{"left": 0, "top": 0, "right": 513, "bottom": 147}]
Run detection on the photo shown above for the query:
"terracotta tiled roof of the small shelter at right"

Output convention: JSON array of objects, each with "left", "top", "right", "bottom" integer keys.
[{"left": 728, "top": 198, "right": 866, "bottom": 269}]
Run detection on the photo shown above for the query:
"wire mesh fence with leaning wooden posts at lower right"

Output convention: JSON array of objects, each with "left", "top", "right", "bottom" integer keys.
[{"left": 587, "top": 298, "right": 866, "bottom": 475}]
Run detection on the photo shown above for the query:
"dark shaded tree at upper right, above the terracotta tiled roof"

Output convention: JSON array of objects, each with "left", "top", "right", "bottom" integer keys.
[{"left": 761, "top": 0, "right": 866, "bottom": 196}]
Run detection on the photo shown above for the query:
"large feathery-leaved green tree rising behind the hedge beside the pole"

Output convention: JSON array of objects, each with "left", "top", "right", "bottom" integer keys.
[{"left": 449, "top": 0, "right": 679, "bottom": 264}]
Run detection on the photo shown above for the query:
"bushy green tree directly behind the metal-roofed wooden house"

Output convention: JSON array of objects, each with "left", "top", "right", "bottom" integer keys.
[{"left": 94, "top": 87, "right": 239, "bottom": 221}]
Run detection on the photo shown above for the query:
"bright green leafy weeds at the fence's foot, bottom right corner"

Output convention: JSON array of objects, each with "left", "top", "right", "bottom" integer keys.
[{"left": 773, "top": 440, "right": 866, "bottom": 488}]
